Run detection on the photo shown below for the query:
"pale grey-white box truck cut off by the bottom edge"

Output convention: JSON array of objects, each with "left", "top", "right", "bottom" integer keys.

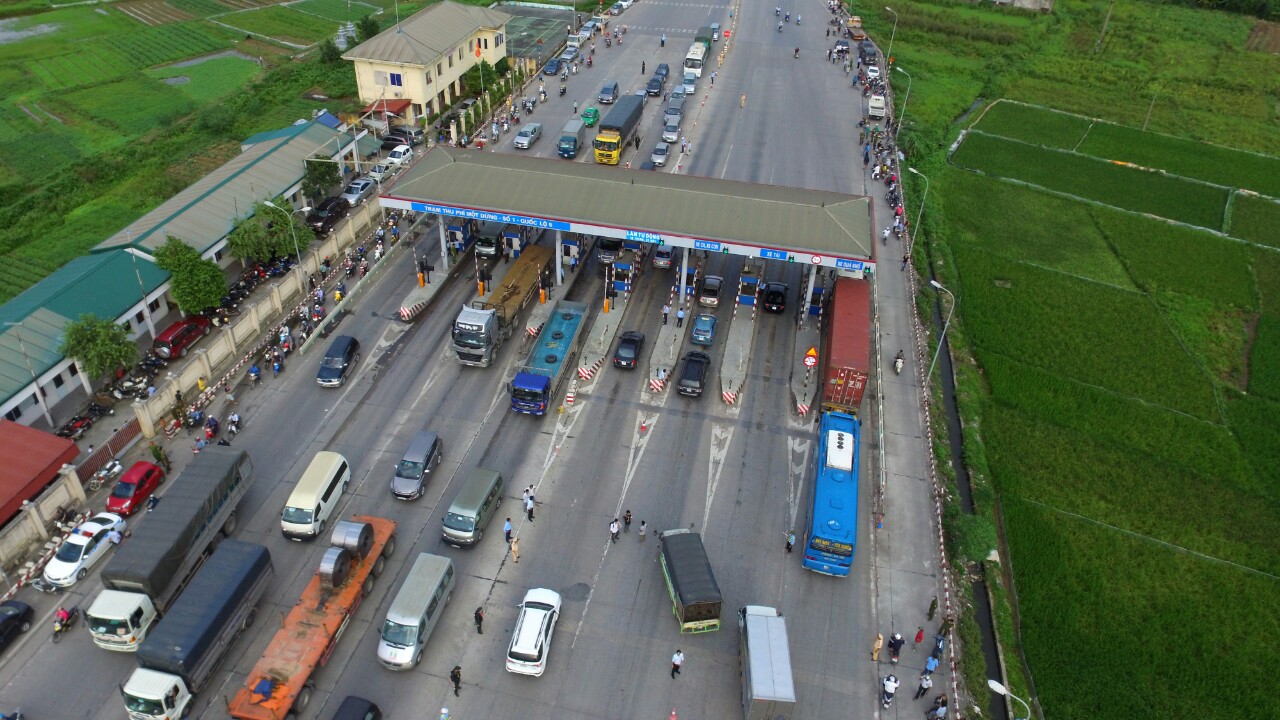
[{"left": 737, "top": 605, "right": 796, "bottom": 720}]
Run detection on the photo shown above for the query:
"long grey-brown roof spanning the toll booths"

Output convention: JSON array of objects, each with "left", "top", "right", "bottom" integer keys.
[{"left": 383, "top": 146, "right": 872, "bottom": 261}]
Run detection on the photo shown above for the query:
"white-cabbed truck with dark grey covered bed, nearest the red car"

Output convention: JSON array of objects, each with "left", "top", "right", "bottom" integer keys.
[{"left": 84, "top": 446, "right": 253, "bottom": 652}]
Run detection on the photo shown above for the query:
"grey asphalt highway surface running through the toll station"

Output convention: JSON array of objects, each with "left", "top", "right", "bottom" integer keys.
[{"left": 0, "top": 0, "right": 908, "bottom": 720}]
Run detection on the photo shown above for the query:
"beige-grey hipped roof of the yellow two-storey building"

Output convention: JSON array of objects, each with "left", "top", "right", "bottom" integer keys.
[{"left": 342, "top": 0, "right": 511, "bottom": 67}]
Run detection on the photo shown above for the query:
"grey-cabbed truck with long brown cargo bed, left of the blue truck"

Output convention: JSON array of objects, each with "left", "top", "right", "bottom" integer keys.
[{"left": 452, "top": 245, "right": 556, "bottom": 368}]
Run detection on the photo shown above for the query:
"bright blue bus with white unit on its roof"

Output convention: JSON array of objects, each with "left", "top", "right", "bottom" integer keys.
[{"left": 804, "top": 413, "right": 858, "bottom": 577}]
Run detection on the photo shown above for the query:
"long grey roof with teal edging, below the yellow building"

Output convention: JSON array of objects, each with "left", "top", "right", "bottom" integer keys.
[{"left": 93, "top": 120, "right": 351, "bottom": 252}]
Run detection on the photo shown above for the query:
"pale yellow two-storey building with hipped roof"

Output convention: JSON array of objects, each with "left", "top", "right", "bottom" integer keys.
[{"left": 343, "top": 0, "right": 511, "bottom": 122}]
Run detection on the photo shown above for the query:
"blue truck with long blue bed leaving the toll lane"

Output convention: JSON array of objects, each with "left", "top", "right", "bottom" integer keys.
[{"left": 511, "top": 300, "right": 586, "bottom": 415}]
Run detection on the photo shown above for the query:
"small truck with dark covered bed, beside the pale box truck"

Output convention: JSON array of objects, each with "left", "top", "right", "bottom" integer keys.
[{"left": 658, "top": 528, "right": 722, "bottom": 633}]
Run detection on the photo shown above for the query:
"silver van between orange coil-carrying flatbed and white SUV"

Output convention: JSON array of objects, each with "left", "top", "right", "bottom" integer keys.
[{"left": 378, "top": 552, "right": 457, "bottom": 670}]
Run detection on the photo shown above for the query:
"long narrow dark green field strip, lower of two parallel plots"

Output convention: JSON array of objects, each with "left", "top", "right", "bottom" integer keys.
[{"left": 951, "top": 132, "right": 1228, "bottom": 229}]
